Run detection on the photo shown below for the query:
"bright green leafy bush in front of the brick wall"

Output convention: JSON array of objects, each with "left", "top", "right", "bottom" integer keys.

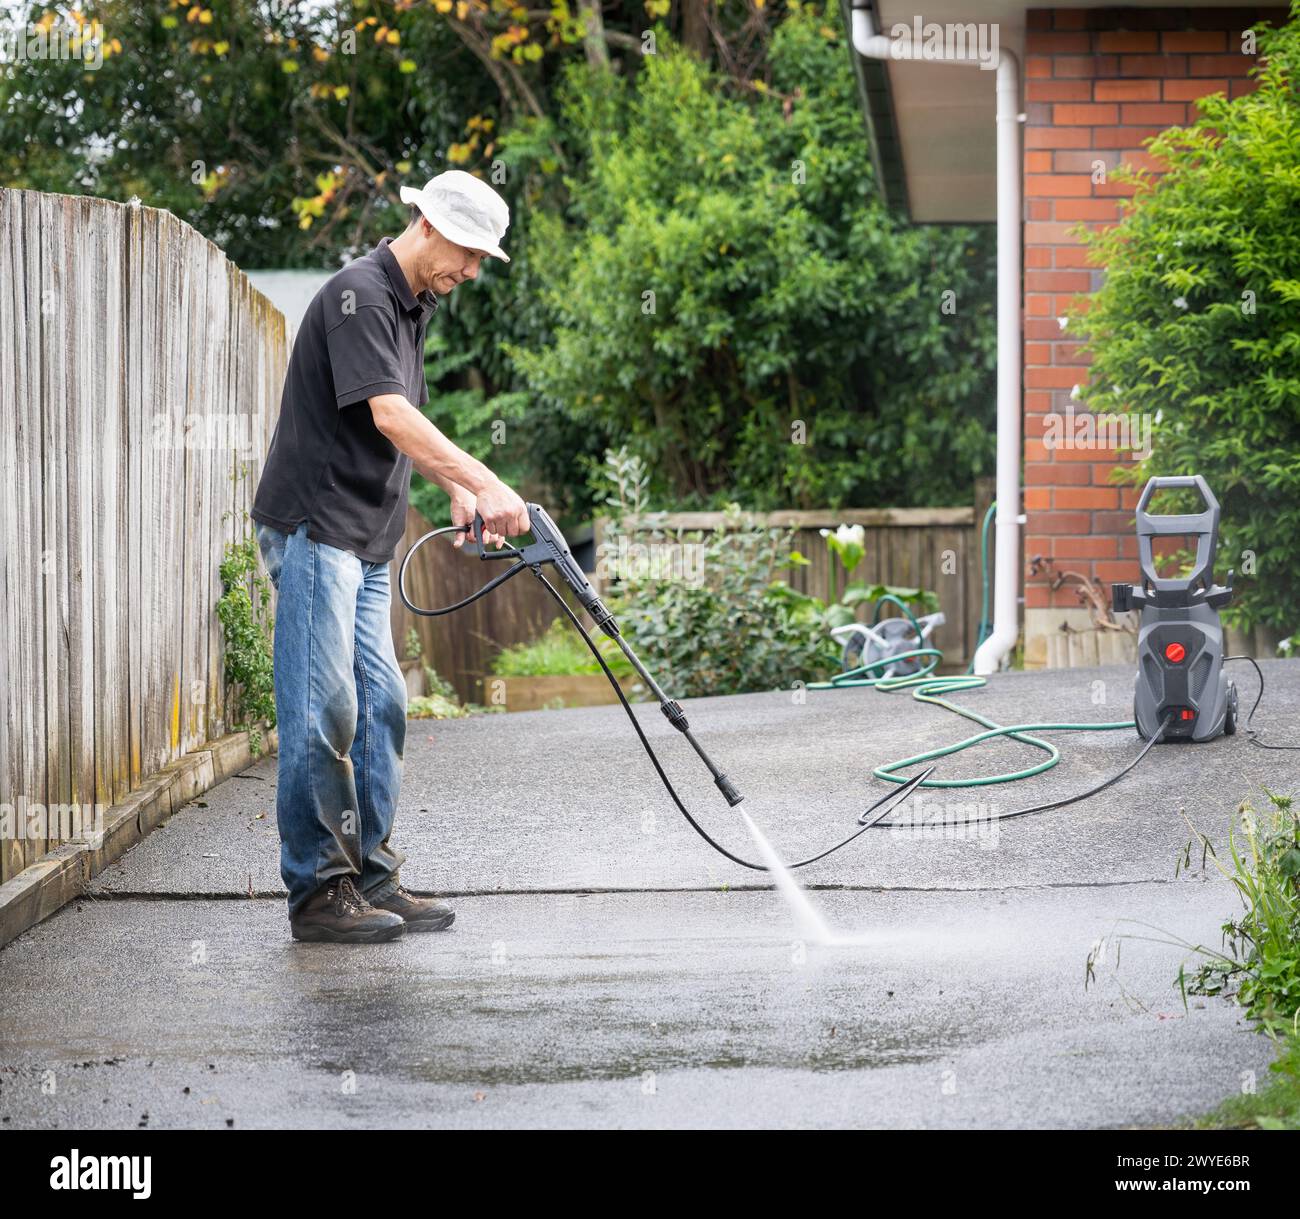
[{"left": 1070, "top": 4, "right": 1300, "bottom": 630}]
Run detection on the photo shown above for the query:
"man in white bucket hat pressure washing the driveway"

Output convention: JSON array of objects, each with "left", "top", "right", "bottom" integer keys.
[{"left": 252, "top": 170, "right": 528, "bottom": 943}]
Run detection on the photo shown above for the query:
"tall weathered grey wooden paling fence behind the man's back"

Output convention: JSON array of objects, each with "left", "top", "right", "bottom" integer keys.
[{"left": 0, "top": 190, "right": 286, "bottom": 880}]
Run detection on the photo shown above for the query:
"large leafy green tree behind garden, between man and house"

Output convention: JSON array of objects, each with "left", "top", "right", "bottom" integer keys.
[{"left": 504, "top": 5, "right": 993, "bottom": 508}]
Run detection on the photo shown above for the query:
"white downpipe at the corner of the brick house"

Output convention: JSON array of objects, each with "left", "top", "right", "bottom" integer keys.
[{"left": 853, "top": 5, "right": 1023, "bottom": 674}]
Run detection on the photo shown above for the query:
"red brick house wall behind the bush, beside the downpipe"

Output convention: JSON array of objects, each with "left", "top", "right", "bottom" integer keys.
[{"left": 1024, "top": 0, "right": 1287, "bottom": 610}]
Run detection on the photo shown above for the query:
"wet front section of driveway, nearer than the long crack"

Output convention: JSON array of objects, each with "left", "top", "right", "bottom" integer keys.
[{"left": 0, "top": 882, "right": 1271, "bottom": 1128}]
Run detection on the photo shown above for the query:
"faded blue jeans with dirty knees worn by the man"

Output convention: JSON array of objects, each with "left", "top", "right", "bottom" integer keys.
[{"left": 256, "top": 522, "right": 406, "bottom": 915}]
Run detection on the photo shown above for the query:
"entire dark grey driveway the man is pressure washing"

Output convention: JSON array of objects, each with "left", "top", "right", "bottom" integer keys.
[{"left": 0, "top": 661, "right": 1300, "bottom": 1127}]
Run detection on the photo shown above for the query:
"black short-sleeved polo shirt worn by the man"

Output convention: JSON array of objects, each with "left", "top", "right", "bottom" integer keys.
[{"left": 251, "top": 238, "right": 438, "bottom": 563}]
